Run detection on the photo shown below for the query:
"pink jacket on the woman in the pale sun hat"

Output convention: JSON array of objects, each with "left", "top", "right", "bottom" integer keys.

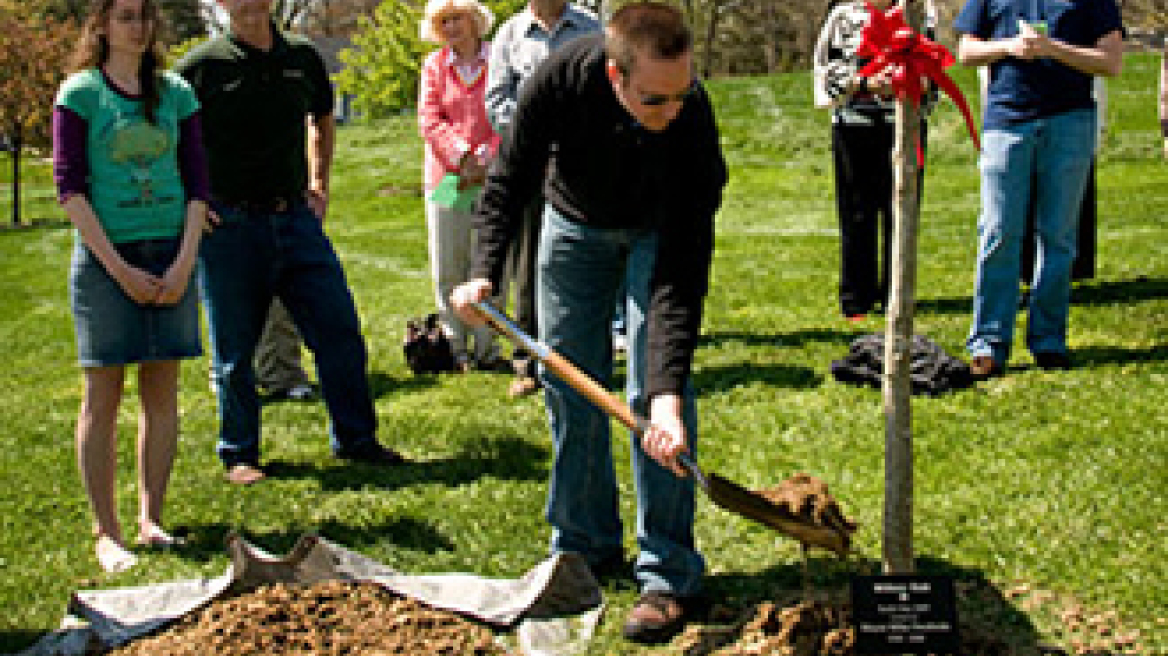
[{"left": 418, "top": 42, "right": 499, "bottom": 189}]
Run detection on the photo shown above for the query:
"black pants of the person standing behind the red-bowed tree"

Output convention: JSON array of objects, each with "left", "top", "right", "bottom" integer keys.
[{"left": 832, "top": 120, "right": 925, "bottom": 315}]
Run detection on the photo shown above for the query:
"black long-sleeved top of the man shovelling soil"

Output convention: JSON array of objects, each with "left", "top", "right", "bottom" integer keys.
[{"left": 471, "top": 34, "right": 726, "bottom": 396}]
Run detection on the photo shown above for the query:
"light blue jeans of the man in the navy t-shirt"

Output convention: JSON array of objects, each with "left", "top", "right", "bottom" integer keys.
[{"left": 966, "top": 109, "right": 1096, "bottom": 365}]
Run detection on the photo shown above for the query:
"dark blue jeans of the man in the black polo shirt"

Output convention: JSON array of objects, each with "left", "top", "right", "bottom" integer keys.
[{"left": 199, "top": 203, "right": 377, "bottom": 467}]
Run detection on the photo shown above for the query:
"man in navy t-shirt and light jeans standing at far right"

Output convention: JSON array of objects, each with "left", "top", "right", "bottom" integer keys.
[{"left": 953, "top": 0, "right": 1124, "bottom": 378}]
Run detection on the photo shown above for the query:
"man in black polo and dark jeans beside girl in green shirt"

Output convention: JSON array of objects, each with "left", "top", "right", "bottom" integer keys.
[{"left": 178, "top": 0, "right": 403, "bottom": 484}]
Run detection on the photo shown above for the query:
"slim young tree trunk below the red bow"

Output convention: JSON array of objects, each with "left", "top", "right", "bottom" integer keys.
[{"left": 883, "top": 0, "right": 922, "bottom": 574}]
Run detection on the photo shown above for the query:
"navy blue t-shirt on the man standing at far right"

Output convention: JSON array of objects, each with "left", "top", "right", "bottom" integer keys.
[{"left": 953, "top": 0, "right": 1124, "bottom": 130}]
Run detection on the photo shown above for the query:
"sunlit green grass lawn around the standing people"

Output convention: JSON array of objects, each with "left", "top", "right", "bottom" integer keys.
[{"left": 0, "top": 55, "right": 1168, "bottom": 655}]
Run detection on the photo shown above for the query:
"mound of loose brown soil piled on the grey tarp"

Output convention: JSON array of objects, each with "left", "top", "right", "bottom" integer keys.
[{"left": 112, "top": 580, "right": 506, "bottom": 656}]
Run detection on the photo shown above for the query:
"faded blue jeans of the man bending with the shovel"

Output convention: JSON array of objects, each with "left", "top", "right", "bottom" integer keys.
[{"left": 536, "top": 205, "right": 705, "bottom": 595}]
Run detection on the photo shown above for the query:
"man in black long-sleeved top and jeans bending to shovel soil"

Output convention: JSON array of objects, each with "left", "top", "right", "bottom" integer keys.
[{"left": 453, "top": 1, "right": 726, "bottom": 642}]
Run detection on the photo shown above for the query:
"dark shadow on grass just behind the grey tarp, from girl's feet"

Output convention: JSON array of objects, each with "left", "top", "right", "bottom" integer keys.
[{"left": 174, "top": 517, "right": 454, "bottom": 563}]
